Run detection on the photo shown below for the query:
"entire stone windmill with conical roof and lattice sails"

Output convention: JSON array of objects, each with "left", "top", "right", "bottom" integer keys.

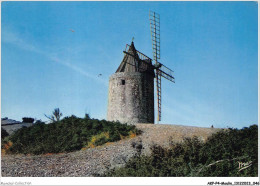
[{"left": 107, "top": 12, "right": 174, "bottom": 124}]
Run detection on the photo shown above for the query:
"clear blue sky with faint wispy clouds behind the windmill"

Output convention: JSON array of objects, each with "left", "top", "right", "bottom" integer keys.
[{"left": 1, "top": 1, "right": 258, "bottom": 128}]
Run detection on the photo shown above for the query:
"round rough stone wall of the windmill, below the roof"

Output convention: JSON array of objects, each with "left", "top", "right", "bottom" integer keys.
[{"left": 107, "top": 72, "right": 154, "bottom": 124}]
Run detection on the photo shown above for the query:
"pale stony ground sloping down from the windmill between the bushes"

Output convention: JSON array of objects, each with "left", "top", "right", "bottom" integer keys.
[{"left": 1, "top": 124, "right": 219, "bottom": 177}]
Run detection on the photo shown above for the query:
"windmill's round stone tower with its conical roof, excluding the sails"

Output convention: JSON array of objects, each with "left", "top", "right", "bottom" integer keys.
[{"left": 107, "top": 42, "right": 155, "bottom": 124}]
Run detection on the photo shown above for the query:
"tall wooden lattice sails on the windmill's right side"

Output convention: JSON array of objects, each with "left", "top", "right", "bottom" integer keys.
[{"left": 149, "top": 11, "right": 175, "bottom": 122}]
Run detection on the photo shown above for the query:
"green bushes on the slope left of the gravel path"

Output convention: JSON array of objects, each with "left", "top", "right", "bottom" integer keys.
[{"left": 5, "top": 115, "right": 139, "bottom": 154}]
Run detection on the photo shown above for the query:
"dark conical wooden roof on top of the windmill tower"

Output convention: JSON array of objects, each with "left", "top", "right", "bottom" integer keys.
[{"left": 116, "top": 42, "right": 153, "bottom": 73}]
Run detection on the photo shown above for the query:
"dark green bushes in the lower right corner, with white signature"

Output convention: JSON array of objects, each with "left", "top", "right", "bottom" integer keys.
[{"left": 102, "top": 125, "right": 258, "bottom": 177}]
